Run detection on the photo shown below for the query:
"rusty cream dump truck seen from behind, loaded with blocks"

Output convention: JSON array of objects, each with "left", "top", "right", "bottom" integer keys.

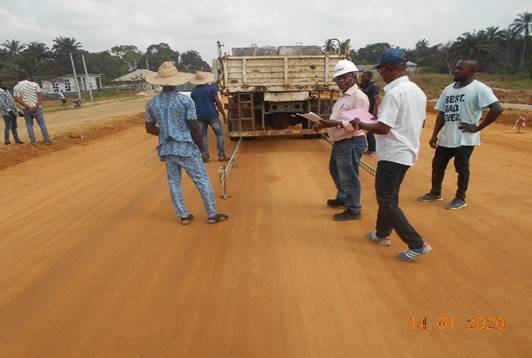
[{"left": 217, "top": 42, "right": 349, "bottom": 140}]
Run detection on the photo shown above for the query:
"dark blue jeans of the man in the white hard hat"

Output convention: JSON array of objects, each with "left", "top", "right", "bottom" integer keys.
[{"left": 329, "top": 136, "right": 366, "bottom": 214}]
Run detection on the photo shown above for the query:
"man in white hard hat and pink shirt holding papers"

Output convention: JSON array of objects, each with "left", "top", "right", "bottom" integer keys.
[{"left": 314, "top": 60, "right": 369, "bottom": 221}]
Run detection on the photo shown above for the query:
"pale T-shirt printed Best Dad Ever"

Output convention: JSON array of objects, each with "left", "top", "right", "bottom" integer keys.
[{"left": 434, "top": 80, "right": 498, "bottom": 148}]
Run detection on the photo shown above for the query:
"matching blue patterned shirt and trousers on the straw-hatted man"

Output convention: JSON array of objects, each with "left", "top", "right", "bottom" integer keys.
[{"left": 145, "top": 91, "right": 217, "bottom": 218}]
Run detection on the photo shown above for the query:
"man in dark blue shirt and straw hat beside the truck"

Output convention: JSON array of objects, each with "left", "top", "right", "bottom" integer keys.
[{"left": 190, "top": 71, "right": 229, "bottom": 163}]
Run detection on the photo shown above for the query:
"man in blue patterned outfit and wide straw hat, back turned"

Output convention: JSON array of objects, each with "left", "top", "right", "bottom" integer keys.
[{"left": 146, "top": 62, "right": 228, "bottom": 225}]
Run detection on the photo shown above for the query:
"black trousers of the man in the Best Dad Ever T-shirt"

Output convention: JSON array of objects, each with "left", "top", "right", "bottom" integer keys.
[{"left": 430, "top": 145, "right": 475, "bottom": 200}]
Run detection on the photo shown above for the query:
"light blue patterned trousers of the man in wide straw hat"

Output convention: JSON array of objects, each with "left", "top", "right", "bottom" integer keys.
[{"left": 164, "top": 155, "right": 217, "bottom": 218}]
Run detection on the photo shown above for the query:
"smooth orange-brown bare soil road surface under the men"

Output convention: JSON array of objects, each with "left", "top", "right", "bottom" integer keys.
[{"left": 0, "top": 99, "right": 532, "bottom": 358}]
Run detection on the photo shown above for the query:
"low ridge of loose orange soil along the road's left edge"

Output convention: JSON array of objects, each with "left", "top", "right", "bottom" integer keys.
[{"left": 0, "top": 113, "right": 144, "bottom": 170}]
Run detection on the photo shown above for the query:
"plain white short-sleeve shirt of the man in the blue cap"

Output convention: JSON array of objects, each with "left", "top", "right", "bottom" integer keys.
[{"left": 375, "top": 76, "right": 427, "bottom": 166}]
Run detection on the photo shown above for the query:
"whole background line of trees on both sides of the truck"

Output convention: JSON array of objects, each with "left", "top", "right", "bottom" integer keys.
[{"left": 0, "top": 12, "right": 532, "bottom": 83}]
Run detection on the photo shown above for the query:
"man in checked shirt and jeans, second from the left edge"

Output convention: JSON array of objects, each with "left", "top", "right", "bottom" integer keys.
[{"left": 13, "top": 75, "right": 52, "bottom": 144}]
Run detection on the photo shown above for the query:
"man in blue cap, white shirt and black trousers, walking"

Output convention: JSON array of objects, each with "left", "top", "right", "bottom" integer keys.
[{"left": 351, "top": 48, "right": 432, "bottom": 261}]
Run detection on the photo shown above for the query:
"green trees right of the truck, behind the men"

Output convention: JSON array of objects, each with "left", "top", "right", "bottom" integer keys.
[{"left": 322, "top": 12, "right": 532, "bottom": 76}]
